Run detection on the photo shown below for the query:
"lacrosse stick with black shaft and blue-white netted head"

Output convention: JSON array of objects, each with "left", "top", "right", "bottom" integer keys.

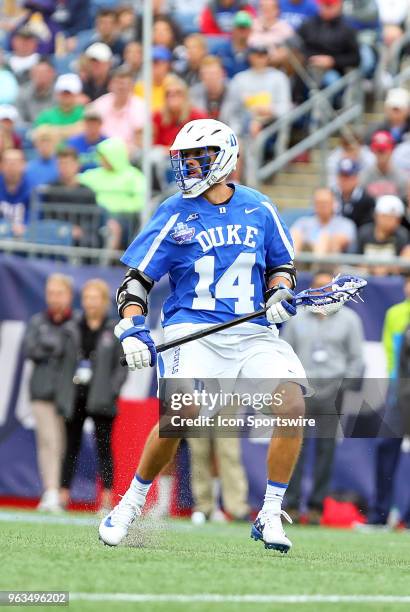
[{"left": 121, "top": 276, "right": 367, "bottom": 366}]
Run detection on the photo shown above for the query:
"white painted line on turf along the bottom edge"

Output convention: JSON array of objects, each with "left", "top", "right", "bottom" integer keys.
[{"left": 70, "top": 593, "right": 410, "bottom": 604}]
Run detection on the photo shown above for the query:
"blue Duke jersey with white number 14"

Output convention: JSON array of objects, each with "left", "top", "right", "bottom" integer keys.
[{"left": 121, "top": 185, "right": 294, "bottom": 326}]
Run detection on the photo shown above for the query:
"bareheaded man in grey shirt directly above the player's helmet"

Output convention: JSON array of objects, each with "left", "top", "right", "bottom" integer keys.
[{"left": 190, "top": 55, "right": 230, "bottom": 123}]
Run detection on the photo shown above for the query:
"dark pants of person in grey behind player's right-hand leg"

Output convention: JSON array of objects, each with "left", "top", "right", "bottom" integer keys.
[{"left": 285, "top": 391, "right": 343, "bottom": 512}]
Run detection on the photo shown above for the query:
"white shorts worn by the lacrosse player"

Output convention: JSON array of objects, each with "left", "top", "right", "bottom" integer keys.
[{"left": 158, "top": 323, "right": 309, "bottom": 390}]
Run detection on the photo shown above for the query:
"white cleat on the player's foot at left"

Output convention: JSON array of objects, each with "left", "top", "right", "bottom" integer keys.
[{"left": 98, "top": 491, "right": 142, "bottom": 546}]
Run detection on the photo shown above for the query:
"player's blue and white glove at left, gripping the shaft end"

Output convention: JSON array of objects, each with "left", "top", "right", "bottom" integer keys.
[{"left": 114, "top": 315, "right": 157, "bottom": 370}]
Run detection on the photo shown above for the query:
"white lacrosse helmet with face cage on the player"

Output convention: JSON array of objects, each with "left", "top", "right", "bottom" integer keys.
[{"left": 170, "top": 119, "right": 239, "bottom": 198}]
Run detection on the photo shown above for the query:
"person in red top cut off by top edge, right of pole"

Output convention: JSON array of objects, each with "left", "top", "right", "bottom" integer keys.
[{"left": 199, "top": 0, "right": 255, "bottom": 35}]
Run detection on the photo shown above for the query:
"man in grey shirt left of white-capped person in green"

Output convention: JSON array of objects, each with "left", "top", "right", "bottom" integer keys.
[{"left": 17, "top": 58, "right": 56, "bottom": 123}]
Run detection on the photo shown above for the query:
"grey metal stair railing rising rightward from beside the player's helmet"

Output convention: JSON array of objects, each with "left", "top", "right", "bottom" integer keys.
[{"left": 246, "top": 69, "right": 363, "bottom": 187}]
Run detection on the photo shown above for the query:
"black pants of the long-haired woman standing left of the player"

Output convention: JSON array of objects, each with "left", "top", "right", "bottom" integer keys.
[{"left": 61, "top": 389, "right": 114, "bottom": 489}]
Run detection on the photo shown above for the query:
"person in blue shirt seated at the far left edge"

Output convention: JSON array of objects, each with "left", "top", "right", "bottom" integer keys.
[{"left": 0, "top": 149, "right": 30, "bottom": 236}]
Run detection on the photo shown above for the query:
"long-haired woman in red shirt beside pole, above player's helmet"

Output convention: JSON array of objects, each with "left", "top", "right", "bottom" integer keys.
[{"left": 152, "top": 74, "right": 208, "bottom": 188}]
